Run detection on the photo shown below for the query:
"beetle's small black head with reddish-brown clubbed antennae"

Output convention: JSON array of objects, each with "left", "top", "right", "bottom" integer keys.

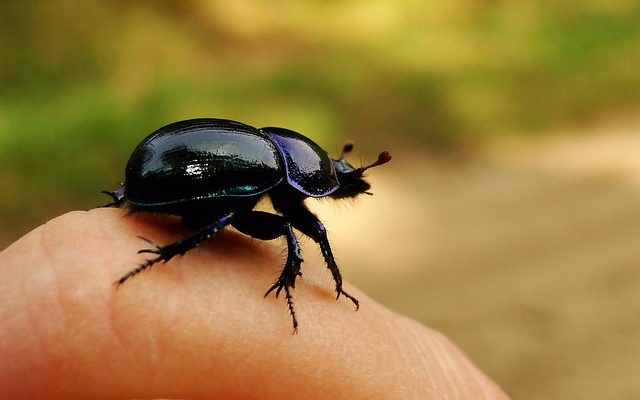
[{"left": 330, "top": 143, "right": 391, "bottom": 199}]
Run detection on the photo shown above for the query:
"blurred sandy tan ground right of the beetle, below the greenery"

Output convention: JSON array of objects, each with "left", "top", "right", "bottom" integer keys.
[{"left": 306, "top": 121, "right": 640, "bottom": 399}]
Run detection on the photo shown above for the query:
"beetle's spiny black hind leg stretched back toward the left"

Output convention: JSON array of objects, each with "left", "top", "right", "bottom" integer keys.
[{"left": 115, "top": 213, "right": 233, "bottom": 286}]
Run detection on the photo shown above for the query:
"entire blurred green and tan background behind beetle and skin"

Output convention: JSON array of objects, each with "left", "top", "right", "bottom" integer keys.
[{"left": 0, "top": 0, "right": 640, "bottom": 399}]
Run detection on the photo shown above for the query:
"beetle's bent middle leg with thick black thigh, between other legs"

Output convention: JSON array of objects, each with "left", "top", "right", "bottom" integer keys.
[{"left": 232, "top": 211, "right": 303, "bottom": 333}]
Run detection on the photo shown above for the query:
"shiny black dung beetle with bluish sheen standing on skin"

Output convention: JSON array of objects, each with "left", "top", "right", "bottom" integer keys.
[{"left": 103, "top": 118, "right": 391, "bottom": 333}]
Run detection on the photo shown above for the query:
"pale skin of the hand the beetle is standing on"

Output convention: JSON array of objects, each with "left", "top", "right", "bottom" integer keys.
[{"left": 0, "top": 209, "right": 507, "bottom": 400}]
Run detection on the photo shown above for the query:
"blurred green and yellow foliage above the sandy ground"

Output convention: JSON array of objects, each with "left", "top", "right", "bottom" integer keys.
[{"left": 0, "top": 0, "right": 640, "bottom": 239}]
